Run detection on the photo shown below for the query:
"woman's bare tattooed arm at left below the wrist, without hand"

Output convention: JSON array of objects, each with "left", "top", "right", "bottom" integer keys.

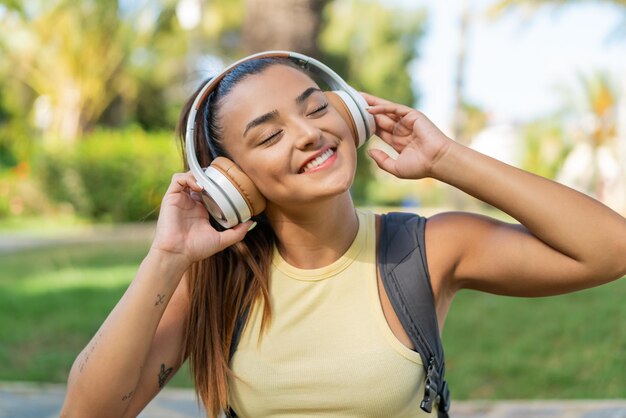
[{"left": 62, "top": 253, "right": 186, "bottom": 417}]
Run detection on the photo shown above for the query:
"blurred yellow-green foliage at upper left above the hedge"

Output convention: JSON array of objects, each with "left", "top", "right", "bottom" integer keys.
[{"left": 0, "top": 0, "right": 243, "bottom": 141}]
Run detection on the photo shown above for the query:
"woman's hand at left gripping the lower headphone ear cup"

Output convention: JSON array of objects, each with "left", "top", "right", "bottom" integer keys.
[{"left": 150, "top": 171, "right": 253, "bottom": 268}]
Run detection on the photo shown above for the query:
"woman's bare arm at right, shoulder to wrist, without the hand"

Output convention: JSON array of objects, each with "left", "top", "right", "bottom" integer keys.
[{"left": 430, "top": 143, "right": 626, "bottom": 296}]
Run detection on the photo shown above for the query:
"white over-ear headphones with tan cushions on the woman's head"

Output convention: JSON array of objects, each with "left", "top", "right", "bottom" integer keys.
[{"left": 185, "top": 51, "right": 376, "bottom": 228}]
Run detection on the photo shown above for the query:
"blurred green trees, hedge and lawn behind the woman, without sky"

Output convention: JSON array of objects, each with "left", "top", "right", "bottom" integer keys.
[{"left": 0, "top": 0, "right": 626, "bottom": 398}]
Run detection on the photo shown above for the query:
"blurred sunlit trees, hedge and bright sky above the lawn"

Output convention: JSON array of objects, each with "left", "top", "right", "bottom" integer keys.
[{"left": 0, "top": 0, "right": 626, "bottom": 222}]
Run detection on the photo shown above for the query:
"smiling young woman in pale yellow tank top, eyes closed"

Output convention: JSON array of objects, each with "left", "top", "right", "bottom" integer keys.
[{"left": 62, "top": 54, "right": 626, "bottom": 417}]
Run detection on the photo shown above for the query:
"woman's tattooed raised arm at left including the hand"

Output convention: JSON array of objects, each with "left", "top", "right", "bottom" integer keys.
[{"left": 61, "top": 173, "right": 250, "bottom": 418}]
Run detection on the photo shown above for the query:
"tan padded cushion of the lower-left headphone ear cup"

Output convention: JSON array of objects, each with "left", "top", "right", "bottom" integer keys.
[{"left": 211, "top": 157, "right": 266, "bottom": 217}]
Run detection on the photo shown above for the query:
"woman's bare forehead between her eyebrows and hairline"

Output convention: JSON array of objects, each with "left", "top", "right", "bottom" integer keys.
[{"left": 219, "top": 64, "right": 317, "bottom": 128}]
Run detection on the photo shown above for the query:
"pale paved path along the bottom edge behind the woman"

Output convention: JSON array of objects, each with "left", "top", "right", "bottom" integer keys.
[{"left": 0, "top": 383, "right": 626, "bottom": 418}]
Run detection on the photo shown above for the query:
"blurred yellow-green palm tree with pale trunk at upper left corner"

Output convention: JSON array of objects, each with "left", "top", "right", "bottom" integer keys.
[{"left": 0, "top": 0, "right": 182, "bottom": 143}]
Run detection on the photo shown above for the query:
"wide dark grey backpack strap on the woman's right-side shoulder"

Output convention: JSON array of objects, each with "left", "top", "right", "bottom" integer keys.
[{"left": 378, "top": 213, "right": 450, "bottom": 418}]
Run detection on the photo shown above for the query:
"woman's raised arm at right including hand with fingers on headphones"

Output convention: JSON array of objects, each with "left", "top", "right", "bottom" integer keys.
[{"left": 366, "top": 96, "right": 626, "bottom": 310}]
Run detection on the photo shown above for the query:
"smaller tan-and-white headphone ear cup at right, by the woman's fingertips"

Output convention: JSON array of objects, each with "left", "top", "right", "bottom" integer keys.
[{"left": 325, "top": 90, "right": 376, "bottom": 148}]
